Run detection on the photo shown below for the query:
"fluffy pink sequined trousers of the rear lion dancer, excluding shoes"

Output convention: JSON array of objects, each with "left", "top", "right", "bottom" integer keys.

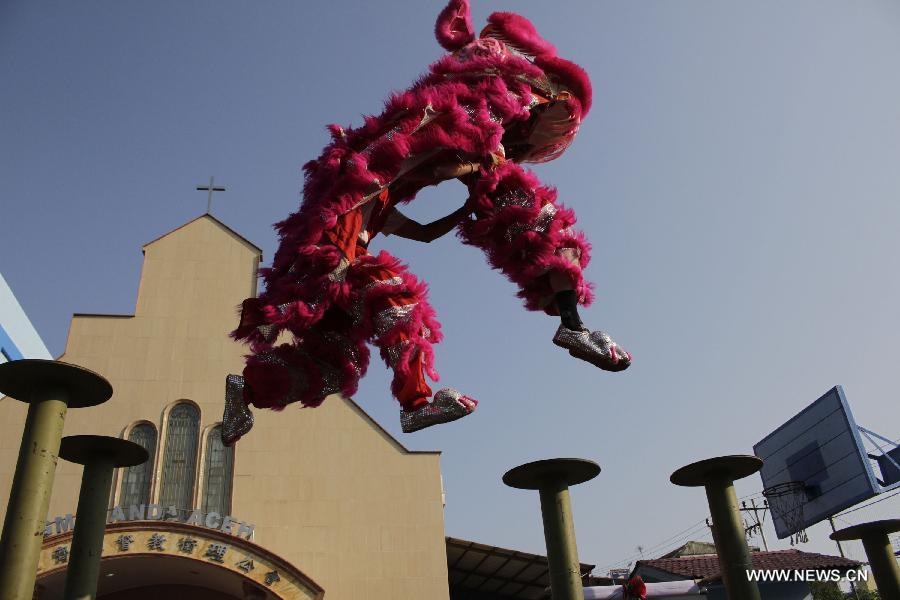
[{"left": 244, "top": 249, "right": 440, "bottom": 409}]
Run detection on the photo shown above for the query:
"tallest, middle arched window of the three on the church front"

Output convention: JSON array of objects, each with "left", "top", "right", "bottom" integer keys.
[{"left": 159, "top": 402, "right": 200, "bottom": 510}]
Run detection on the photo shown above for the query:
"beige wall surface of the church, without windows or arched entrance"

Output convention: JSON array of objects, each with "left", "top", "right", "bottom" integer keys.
[{"left": 0, "top": 216, "right": 448, "bottom": 600}]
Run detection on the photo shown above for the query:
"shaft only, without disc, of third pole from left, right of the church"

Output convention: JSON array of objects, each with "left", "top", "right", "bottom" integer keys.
[{"left": 539, "top": 481, "right": 584, "bottom": 600}]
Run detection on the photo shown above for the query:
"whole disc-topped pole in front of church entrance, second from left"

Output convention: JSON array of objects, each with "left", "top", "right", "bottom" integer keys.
[{"left": 59, "top": 435, "right": 150, "bottom": 600}]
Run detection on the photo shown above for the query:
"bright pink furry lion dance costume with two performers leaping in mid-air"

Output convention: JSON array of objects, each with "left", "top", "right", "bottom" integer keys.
[{"left": 223, "top": 0, "right": 631, "bottom": 444}]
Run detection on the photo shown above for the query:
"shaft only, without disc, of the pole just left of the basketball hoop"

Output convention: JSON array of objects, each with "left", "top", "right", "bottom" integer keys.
[{"left": 705, "top": 480, "right": 760, "bottom": 600}]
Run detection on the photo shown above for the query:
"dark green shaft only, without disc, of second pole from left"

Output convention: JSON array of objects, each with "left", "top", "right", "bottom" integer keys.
[{"left": 63, "top": 456, "right": 114, "bottom": 600}]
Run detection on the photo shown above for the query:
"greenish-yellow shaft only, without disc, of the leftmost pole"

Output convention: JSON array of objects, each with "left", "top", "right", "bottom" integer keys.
[{"left": 0, "top": 388, "right": 68, "bottom": 600}]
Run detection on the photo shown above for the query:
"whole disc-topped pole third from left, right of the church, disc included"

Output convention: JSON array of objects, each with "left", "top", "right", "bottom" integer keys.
[{"left": 503, "top": 458, "right": 600, "bottom": 600}]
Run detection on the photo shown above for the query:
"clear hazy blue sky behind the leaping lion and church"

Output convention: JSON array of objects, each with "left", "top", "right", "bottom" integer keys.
[{"left": 0, "top": 0, "right": 900, "bottom": 569}]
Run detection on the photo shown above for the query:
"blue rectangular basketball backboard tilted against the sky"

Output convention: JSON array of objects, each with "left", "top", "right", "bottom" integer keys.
[{"left": 753, "top": 386, "right": 882, "bottom": 539}]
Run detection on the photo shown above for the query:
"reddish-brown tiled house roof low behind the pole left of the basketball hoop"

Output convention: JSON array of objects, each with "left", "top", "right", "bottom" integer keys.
[{"left": 635, "top": 550, "right": 862, "bottom": 579}]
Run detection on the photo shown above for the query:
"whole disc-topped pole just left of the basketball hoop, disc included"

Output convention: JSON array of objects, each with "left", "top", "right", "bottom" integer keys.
[{"left": 670, "top": 455, "right": 763, "bottom": 600}]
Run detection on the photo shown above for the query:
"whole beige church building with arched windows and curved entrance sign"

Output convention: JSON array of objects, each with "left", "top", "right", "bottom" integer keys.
[{"left": 0, "top": 214, "right": 450, "bottom": 600}]
